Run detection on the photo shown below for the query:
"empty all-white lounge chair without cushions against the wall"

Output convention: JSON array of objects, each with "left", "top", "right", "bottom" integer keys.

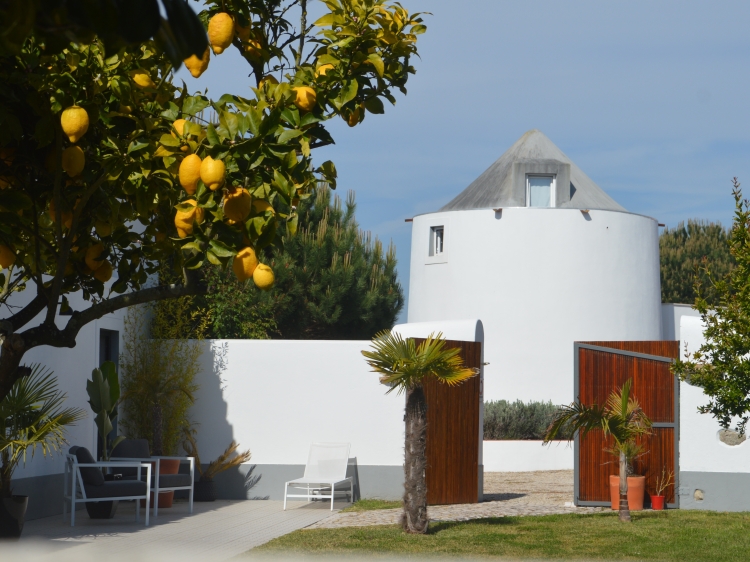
[{"left": 284, "top": 443, "right": 354, "bottom": 511}]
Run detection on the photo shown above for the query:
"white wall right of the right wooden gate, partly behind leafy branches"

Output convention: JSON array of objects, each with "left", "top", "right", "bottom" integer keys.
[{"left": 680, "top": 316, "right": 750, "bottom": 473}]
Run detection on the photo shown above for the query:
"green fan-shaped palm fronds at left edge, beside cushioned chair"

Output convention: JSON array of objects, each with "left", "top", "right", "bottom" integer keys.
[{"left": 0, "top": 364, "right": 86, "bottom": 498}]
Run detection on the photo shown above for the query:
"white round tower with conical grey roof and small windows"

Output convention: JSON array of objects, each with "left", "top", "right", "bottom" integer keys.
[{"left": 408, "top": 130, "right": 661, "bottom": 404}]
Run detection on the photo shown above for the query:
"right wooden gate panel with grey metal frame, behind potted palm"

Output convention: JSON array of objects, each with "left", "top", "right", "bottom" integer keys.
[{"left": 575, "top": 341, "right": 680, "bottom": 507}]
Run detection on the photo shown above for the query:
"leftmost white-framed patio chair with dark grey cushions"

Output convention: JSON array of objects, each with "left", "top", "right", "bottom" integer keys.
[{"left": 63, "top": 447, "right": 151, "bottom": 527}]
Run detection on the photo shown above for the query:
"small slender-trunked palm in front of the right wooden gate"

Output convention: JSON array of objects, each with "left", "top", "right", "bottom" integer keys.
[{"left": 544, "top": 379, "right": 651, "bottom": 521}]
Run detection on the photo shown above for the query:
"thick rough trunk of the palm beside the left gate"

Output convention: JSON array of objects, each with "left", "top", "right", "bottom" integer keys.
[{"left": 401, "top": 385, "right": 429, "bottom": 534}]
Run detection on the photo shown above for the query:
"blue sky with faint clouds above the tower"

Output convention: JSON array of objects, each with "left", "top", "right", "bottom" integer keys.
[{"left": 178, "top": 0, "right": 750, "bottom": 320}]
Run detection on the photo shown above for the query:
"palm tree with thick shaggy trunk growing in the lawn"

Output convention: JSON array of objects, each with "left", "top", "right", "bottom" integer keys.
[{"left": 362, "top": 330, "right": 478, "bottom": 533}]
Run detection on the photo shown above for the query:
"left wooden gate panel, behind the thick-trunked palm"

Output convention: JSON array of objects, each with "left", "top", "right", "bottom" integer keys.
[{"left": 415, "top": 338, "right": 482, "bottom": 505}]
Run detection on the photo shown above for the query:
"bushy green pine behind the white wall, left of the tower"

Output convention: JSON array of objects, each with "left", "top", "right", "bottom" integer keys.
[{"left": 204, "top": 186, "right": 404, "bottom": 339}]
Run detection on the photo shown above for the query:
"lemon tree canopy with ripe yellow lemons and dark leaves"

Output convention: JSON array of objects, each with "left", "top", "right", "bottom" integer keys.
[{"left": 0, "top": 0, "right": 424, "bottom": 398}]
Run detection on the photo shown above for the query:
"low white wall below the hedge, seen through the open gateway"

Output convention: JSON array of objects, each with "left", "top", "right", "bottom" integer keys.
[{"left": 484, "top": 441, "right": 573, "bottom": 472}]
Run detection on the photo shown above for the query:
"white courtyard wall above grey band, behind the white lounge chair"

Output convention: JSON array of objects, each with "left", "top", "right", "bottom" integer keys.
[{"left": 190, "top": 340, "right": 404, "bottom": 466}]
